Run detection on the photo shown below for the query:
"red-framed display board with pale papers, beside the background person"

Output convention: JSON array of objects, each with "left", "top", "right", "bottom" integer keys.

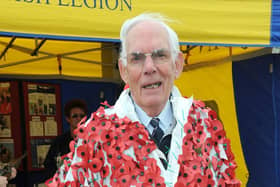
[{"left": 23, "top": 82, "right": 62, "bottom": 171}]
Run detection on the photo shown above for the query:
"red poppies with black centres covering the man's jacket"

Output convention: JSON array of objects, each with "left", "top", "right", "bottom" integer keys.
[{"left": 45, "top": 101, "right": 241, "bottom": 187}]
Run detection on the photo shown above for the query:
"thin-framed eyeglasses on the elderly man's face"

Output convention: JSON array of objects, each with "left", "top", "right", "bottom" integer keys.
[{"left": 127, "top": 49, "right": 171, "bottom": 66}]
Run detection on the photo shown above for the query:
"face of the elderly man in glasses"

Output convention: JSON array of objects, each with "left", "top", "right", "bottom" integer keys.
[{"left": 119, "top": 21, "right": 183, "bottom": 117}]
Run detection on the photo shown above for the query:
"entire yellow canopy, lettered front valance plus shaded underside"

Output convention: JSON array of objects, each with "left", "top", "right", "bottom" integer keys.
[{"left": 0, "top": 0, "right": 272, "bottom": 81}]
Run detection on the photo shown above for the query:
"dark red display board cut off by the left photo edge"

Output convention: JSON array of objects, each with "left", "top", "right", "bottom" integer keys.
[{"left": 0, "top": 81, "right": 24, "bottom": 171}]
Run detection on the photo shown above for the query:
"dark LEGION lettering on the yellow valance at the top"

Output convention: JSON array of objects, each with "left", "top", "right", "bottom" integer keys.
[{"left": 15, "top": 0, "right": 132, "bottom": 11}]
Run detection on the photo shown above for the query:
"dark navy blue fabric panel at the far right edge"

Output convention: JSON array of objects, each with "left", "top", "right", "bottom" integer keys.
[{"left": 232, "top": 54, "right": 280, "bottom": 187}]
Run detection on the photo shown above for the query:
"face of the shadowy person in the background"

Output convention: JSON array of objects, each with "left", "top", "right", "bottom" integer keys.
[{"left": 66, "top": 108, "right": 86, "bottom": 135}]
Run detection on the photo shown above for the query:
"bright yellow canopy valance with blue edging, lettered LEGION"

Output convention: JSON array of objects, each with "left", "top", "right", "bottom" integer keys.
[{"left": 0, "top": 0, "right": 280, "bottom": 46}]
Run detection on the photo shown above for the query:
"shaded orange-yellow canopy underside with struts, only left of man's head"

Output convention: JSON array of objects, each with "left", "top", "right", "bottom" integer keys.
[{"left": 0, "top": 37, "right": 119, "bottom": 79}]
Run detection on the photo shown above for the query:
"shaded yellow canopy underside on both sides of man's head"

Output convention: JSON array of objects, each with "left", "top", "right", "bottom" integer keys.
[{"left": 0, "top": 37, "right": 269, "bottom": 81}]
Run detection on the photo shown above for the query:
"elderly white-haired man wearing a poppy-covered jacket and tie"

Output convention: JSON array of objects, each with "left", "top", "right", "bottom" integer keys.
[{"left": 46, "top": 14, "right": 240, "bottom": 187}]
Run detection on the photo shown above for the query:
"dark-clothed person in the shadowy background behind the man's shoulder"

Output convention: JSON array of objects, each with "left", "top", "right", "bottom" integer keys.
[{"left": 44, "top": 99, "right": 87, "bottom": 180}]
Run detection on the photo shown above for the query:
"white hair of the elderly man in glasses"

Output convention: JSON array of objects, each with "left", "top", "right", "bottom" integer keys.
[{"left": 120, "top": 13, "right": 180, "bottom": 66}]
